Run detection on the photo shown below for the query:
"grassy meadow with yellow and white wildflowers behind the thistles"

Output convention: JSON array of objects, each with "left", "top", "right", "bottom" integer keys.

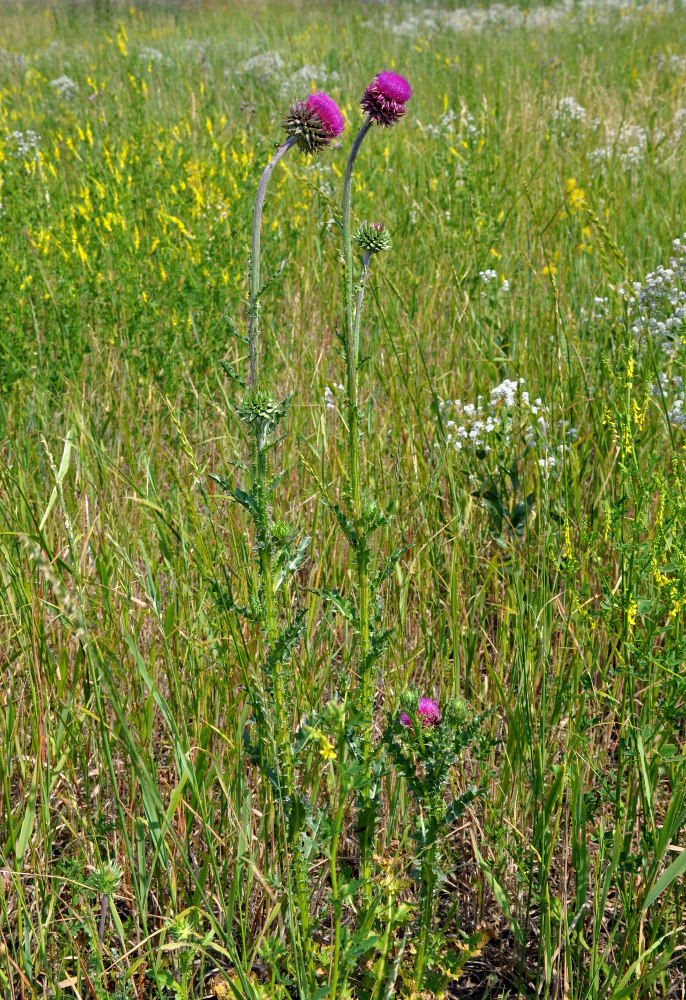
[{"left": 0, "top": 0, "right": 686, "bottom": 1000}]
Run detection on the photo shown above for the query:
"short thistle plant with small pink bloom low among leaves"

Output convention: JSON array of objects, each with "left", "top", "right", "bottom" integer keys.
[{"left": 384, "top": 689, "right": 485, "bottom": 992}]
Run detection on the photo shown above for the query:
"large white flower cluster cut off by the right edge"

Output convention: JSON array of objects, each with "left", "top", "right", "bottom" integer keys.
[{"left": 629, "top": 233, "right": 686, "bottom": 352}]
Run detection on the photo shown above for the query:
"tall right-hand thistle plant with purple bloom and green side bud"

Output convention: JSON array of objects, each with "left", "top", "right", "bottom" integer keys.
[{"left": 336, "top": 72, "right": 412, "bottom": 901}]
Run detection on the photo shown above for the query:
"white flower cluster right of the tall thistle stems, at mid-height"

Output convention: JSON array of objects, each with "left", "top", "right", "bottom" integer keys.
[{"left": 439, "top": 378, "right": 548, "bottom": 451}]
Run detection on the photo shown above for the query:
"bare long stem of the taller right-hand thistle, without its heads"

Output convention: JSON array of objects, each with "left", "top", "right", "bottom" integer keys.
[{"left": 343, "top": 117, "right": 374, "bottom": 903}]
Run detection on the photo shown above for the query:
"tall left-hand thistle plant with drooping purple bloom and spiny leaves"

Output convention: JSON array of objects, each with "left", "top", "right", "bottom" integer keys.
[{"left": 217, "top": 92, "right": 344, "bottom": 986}]
